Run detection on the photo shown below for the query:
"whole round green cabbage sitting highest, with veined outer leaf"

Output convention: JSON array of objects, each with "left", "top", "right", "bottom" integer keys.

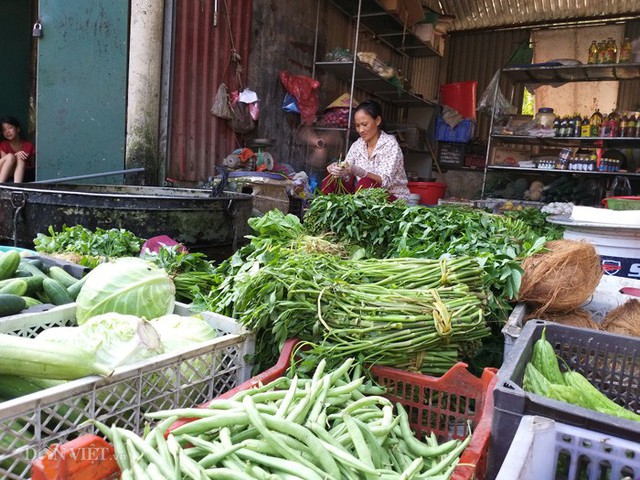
[{"left": 76, "top": 257, "right": 176, "bottom": 325}]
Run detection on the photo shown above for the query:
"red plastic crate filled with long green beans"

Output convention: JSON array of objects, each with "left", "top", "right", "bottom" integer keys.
[{"left": 33, "top": 340, "right": 497, "bottom": 480}]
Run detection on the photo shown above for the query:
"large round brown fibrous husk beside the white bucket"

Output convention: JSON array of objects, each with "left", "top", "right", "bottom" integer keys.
[{"left": 518, "top": 240, "right": 602, "bottom": 312}]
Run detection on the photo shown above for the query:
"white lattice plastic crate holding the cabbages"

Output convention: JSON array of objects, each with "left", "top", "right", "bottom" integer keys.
[{"left": 0, "top": 303, "right": 255, "bottom": 479}]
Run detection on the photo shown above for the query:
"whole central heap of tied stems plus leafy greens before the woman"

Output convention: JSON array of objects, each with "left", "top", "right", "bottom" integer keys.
[{"left": 194, "top": 189, "right": 560, "bottom": 374}]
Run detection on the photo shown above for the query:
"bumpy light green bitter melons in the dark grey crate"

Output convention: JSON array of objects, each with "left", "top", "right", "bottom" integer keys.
[{"left": 523, "top": 329, "right": 640, "bottom": 422}]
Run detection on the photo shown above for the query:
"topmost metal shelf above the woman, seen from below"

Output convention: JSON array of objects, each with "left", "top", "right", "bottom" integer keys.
[{"left": 332, "top": 0, "right": 441, "bottom": 57}]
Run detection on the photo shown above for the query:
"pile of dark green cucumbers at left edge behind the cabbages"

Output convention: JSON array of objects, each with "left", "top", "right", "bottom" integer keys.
[{"left": 0, "top": 250, "right": 84, "bottom": 317}]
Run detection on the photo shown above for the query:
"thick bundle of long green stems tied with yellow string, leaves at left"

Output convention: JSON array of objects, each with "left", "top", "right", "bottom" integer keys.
[{"left": 194, "top": 210, "right": 490, "bottom": 374}]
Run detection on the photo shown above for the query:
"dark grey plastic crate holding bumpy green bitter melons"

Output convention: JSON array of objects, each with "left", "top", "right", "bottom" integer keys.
[{"left": 487, "top": 320, "right": 640, "bottom": 478}]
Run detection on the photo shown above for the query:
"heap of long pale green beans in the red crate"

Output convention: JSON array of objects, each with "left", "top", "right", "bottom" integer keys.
[{"left": 96, "top": 359, "right": 471, "bottom": 480}]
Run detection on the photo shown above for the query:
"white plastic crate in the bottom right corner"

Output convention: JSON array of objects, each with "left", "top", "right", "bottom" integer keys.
[{"left": 496, "top": 415, "right": 640, "bottom": 480}]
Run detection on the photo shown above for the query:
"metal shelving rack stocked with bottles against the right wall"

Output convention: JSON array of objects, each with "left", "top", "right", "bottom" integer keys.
[{"left": 481, "top": 63, "right": 640, "bottom": 204}]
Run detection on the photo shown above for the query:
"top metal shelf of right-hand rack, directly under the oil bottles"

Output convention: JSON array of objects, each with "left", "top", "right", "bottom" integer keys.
[{"left": 502, "top": 63, "right": 640, "bottom": 84}]
